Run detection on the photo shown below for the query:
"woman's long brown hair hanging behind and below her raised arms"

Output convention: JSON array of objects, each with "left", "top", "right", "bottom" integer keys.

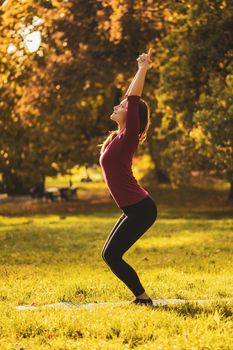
[{"left": 98, "top": 98, "right": 150, "bottom": 154}]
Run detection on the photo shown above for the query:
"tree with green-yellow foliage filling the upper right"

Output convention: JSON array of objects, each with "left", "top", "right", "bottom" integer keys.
[{"left": 150, "top": 0, "right": 233, "bottom": 198}]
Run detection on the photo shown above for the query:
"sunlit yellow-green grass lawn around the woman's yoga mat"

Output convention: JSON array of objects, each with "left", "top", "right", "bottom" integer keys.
[{"left": 0, "top": 184, "right": 233, "bottom": 350}]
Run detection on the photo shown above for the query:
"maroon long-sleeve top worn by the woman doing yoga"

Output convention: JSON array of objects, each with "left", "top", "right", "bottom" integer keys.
[{"left": 99, "top": 95, "right": 149, "bottom": 208}]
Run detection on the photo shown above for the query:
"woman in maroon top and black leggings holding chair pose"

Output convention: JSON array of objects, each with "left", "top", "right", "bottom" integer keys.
[{"left": 99, "top": 49, "right": 157, "bottom": 305}]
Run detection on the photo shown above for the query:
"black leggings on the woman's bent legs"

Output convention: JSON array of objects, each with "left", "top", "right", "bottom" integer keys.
[{"left": 101, "top": 196, "right": 157, "bottom": 297}]
